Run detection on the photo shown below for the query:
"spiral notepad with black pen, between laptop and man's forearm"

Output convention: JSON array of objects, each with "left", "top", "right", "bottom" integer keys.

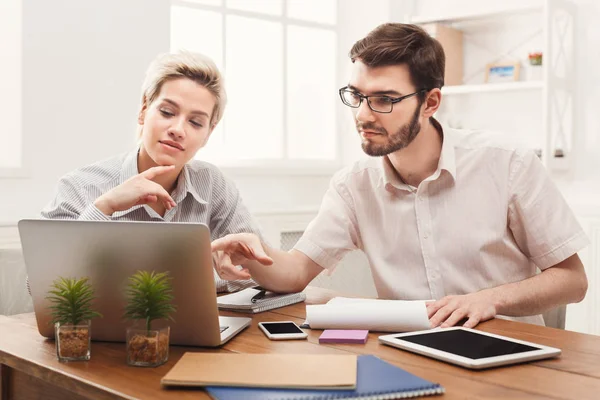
[{"left": 217, "top": 287, "right": 306, "bottom": 313}]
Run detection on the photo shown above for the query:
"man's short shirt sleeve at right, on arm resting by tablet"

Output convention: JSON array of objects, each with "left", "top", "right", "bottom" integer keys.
[{"left": 508, "top": 151, "right": 590, "bottom": 270}]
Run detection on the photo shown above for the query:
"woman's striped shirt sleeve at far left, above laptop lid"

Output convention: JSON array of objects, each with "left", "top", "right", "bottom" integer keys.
[{"left": 41, "top": 175, "right": 111, "bottom": 221}]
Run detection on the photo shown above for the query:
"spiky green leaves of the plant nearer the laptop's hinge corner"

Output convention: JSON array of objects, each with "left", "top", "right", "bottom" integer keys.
[{"left": 125, "top": 271, "right": 176, "bottom": 332}]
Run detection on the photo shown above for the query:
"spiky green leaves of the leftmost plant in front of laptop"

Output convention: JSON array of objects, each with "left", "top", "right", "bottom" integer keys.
[{"left": 46, "top": 277, "right": 102, "bottom": 325}]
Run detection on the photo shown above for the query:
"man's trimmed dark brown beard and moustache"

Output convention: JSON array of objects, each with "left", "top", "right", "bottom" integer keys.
[{"left": 356, "top": 101, "right": 423, "bottom": 157}]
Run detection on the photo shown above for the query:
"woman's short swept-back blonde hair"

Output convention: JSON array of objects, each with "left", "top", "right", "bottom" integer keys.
[{"left": 142, "top": 51, "right": 227, "bottom": 127}]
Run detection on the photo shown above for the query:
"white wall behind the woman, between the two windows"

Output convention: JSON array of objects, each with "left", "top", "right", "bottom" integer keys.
[{"left": 0, "top": 0, "right": 169, "bottom": 222}]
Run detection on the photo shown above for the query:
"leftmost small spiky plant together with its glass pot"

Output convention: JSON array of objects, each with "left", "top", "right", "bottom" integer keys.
[{"left": 46, "top": 278, "right": 102, "bottom": 361}]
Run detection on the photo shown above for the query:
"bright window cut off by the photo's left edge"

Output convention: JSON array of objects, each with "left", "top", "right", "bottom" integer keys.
[{"left": 0, "top": 0, "right": 23, "bottom": 177}]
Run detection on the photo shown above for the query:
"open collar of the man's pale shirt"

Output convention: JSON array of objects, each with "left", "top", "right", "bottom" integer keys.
[{"left": 381, "top": 121, "right": 456, "bottom": 191}]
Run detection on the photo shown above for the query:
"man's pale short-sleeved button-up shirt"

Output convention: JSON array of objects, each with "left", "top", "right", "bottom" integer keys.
[{"left": 295, "top": 127, "right": 589, "bottom": 324}]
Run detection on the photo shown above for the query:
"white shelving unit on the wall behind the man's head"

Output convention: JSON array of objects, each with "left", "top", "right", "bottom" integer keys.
[{"left": 407, "top": 0, "right": 576, "bottom": 173}]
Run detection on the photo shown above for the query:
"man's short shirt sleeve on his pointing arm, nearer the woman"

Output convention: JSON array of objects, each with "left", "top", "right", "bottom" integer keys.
[{"left": 294, "top": 171, "right": 362, "bottom": 272}]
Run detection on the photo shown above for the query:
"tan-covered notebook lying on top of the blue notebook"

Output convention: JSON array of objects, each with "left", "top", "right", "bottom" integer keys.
[{"left": 160, "top": 352, "right": 357, "bottom": 390}]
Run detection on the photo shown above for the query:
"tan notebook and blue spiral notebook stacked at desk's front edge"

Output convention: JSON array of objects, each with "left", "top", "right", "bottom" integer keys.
[{"left": 161, "top": 353, "right": 444, "bottom": 400}]
